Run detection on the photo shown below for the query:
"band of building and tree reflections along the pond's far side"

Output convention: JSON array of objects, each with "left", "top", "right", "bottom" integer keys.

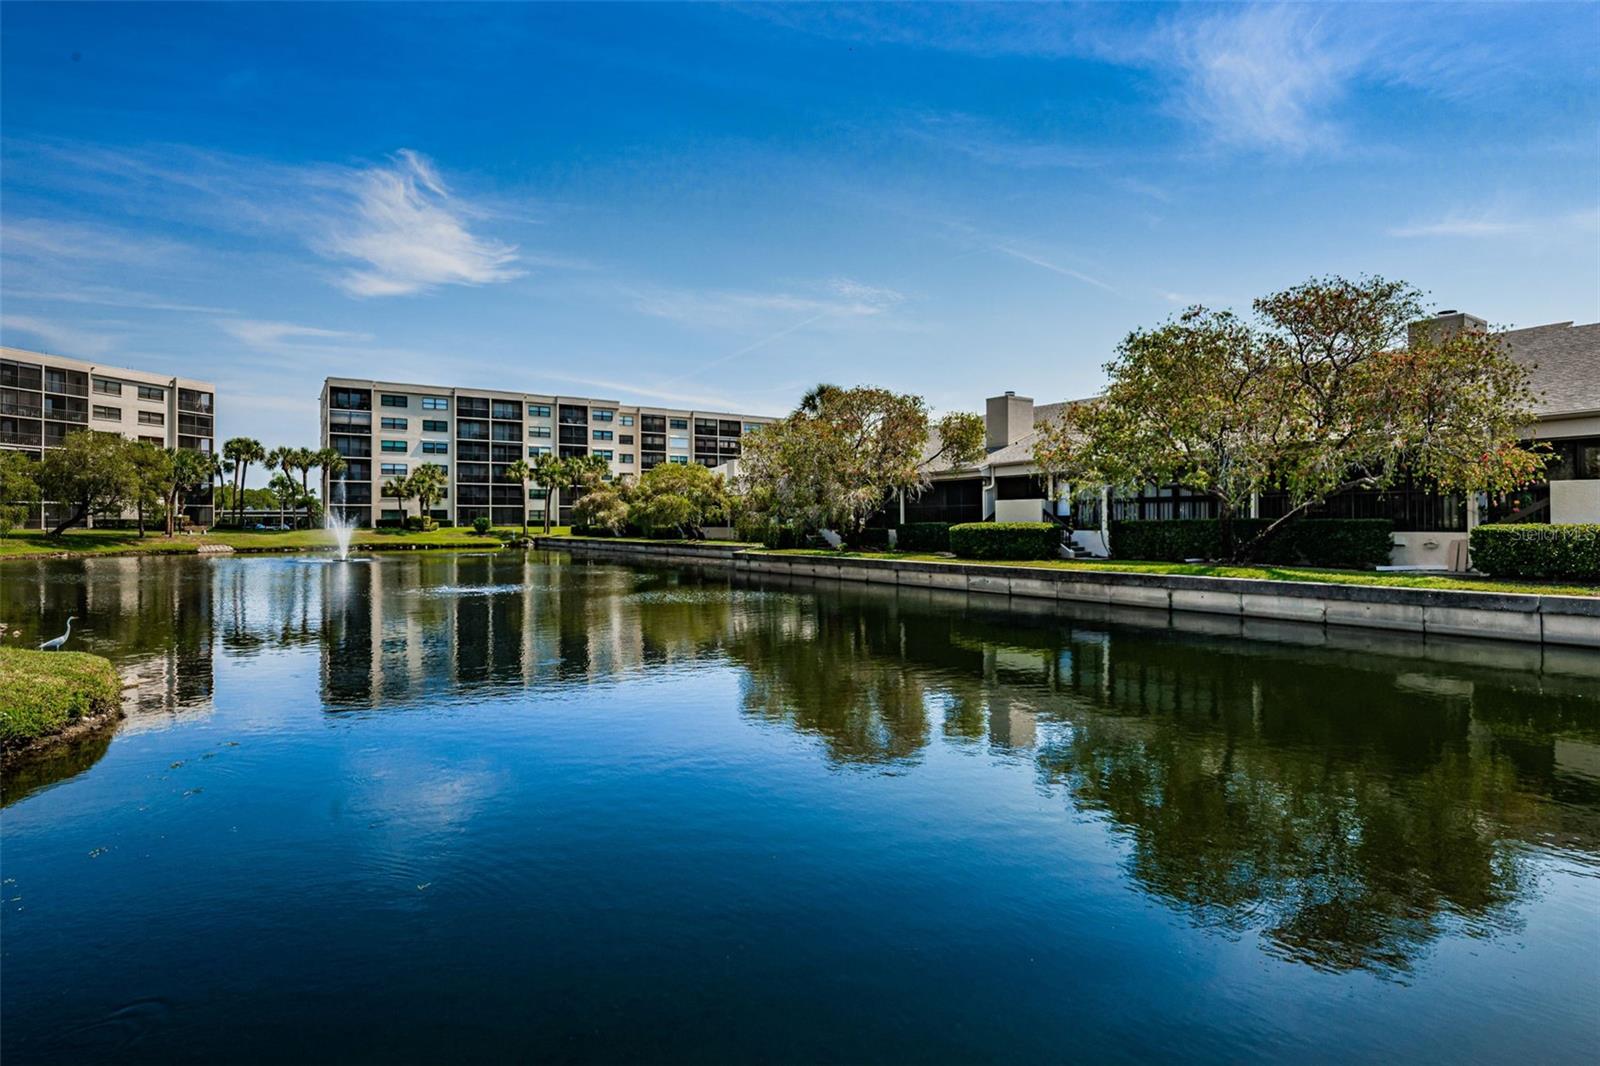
[{"left": 0, "top": 554, "right": 1600, "bottom": 975}]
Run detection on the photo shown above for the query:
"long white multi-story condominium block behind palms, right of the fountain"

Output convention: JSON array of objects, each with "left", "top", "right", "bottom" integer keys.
[{"left": 322, "top": 378, "right": 773, "bottom": 525}]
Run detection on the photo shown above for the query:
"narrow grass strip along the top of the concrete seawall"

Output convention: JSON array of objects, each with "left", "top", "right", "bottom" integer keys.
[{"left": 773, "top": 547, "right": 1600, "bottom": 595}]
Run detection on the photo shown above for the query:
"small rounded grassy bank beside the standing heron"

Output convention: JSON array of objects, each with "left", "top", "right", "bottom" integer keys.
[{"left": 0, "top": 648, "right": 122, "bottom": 747}]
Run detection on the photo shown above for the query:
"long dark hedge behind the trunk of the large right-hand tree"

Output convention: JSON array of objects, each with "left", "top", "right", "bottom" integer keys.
[{"left": 1110, "top": 519, "right": 1394, "bottom": 570}]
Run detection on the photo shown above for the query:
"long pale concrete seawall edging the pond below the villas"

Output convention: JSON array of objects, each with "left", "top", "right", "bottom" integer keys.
[{"left": 536, "top": 536, "right": 1600, "bottom": 648}]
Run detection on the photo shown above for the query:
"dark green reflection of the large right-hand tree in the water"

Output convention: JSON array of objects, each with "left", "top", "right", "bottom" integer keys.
[{"left": 1038, "top": 640, "right": 1587, "bottom": 970}]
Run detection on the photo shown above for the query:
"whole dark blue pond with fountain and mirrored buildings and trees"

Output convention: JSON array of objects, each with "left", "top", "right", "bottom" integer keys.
[{"left": 0, "top": 552, "right": 1600, "bottom": 1066}]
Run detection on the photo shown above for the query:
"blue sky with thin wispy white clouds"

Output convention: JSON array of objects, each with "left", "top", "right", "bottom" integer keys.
[{"left": 0, "top": 3, "right": 1600, "bottom": 464}]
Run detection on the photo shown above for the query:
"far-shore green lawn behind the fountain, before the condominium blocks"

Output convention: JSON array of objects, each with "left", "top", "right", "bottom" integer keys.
[{"left": 0, "top": 527, "right": 566, "bottom": 559}]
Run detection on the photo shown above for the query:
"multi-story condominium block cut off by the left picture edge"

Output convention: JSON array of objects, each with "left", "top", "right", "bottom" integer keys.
[{"left": 0, "top": 347, "right": 216, "bottom": 525}]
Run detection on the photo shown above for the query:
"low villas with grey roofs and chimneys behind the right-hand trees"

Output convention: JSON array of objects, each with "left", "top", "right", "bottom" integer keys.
[{"left": 921, "top": 311, "right": 1600, "bottom": 567}]
